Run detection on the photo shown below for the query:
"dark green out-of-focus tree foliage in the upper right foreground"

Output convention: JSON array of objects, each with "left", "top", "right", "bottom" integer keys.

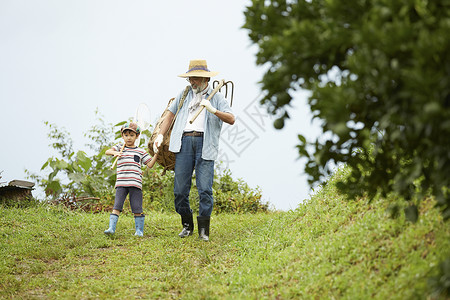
[{"left": 243, "top": 0, "right": 450, "bottom": 219}]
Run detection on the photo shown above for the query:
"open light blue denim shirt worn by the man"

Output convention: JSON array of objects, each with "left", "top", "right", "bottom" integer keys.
[{"left": 169, "top": 86, "right": 233, "bottom": 160}]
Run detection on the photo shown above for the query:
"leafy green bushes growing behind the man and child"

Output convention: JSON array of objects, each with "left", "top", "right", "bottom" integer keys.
[{"left": 27, "top": 112, "right": 268, "bottom": 213}]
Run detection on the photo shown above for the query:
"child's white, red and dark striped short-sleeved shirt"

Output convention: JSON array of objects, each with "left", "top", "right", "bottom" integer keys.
[{"left": 113, "top": 145, "right": 151, "bottom": 190}]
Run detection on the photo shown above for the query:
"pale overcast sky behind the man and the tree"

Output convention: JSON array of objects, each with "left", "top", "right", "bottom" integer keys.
[{"left": 0, "top": 0, "right": 321, "bottom": 211}]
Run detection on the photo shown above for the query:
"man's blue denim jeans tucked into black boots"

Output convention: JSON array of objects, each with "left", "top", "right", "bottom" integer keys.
[{"left": 173, "top": 136, "right": 214, "bottom": 217}]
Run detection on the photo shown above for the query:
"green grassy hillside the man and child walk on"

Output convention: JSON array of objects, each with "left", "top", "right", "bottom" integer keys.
[{"left": 0, "top": 173, "right": 450, "bottom": 299}]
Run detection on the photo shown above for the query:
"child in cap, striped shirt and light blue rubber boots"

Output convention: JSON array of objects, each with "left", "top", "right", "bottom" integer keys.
[{"left": 105, "top": 122, "right": 158, "bottom": 236}]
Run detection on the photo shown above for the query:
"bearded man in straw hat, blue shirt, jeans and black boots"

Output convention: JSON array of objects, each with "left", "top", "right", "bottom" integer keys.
[{"left": 153, "top": 60, "right": 235, "bottom": 241}]
